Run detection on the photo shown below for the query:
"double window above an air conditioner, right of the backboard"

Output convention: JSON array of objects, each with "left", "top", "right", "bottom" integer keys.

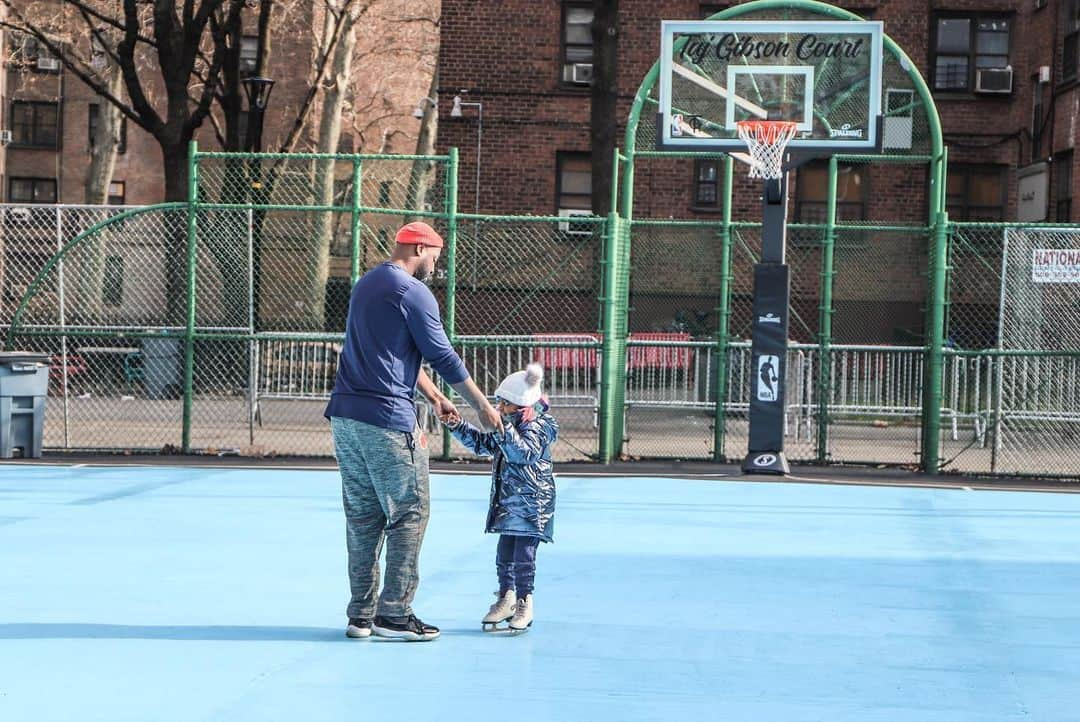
[{"left": 932, "top": 16, "right": 1010, "bottom": 91}]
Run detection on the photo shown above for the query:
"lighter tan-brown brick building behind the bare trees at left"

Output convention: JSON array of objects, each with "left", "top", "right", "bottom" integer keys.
[{"left": 0, "top": 0, "right": 438, "bottom": 328}]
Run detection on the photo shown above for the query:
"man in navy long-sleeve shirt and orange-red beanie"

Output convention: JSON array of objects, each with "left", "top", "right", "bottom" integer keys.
[{"left": 326, "top": 222, "right": 500, "bottom": 641}]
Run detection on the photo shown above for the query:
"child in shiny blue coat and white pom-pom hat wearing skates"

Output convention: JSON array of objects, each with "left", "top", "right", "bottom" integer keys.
[{"left": 442, "top": 364, "right": 558, "bottom": 634}]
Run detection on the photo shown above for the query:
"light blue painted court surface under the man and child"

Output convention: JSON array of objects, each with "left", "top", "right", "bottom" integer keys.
[{"left": 0, "top": 465, "right": 1080, "bottom": 722}]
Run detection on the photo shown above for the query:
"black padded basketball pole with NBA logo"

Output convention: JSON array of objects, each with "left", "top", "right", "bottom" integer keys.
[{"left": 742, "top": 171, "right": 791, "bottom": 474}]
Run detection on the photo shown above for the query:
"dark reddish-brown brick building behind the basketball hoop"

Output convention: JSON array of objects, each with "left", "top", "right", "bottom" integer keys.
[{"left": 438, "top": 0, "right": 1080, "bottom": 342}]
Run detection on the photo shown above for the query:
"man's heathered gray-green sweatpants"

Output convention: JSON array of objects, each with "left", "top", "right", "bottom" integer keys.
[{"left": 330, "top": 417, "right": 431, "bottom": 619}]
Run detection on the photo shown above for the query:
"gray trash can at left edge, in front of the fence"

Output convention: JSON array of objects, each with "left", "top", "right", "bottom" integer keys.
[{"left": 0, "top": 351, "right": 49, "bottom": 459}]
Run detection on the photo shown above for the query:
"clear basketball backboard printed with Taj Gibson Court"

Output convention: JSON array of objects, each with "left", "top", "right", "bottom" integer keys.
[{"left": 657, "top": 21, "right": 882, "bottom": 153}]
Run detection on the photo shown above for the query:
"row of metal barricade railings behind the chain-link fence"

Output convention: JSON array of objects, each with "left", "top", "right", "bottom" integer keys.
[{"left": 208, "top": 335, "right": 1080, "bottom": 461}]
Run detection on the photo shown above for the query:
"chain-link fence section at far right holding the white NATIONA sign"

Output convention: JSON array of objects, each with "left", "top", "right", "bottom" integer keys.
[{"left": 943, "top": 223, "right": 1080, "bottom": 476}]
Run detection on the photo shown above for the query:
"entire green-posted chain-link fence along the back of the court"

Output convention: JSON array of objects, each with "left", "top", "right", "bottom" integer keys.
[{"left": 0, "top": 156, "right": 1080, "bottom": 476}]
